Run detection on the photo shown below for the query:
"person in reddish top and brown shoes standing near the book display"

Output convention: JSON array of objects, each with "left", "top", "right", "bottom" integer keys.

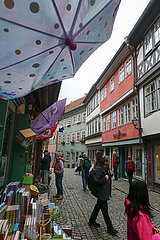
[{"left": 54, "top": 152, "right": 64, "bottom": 200}]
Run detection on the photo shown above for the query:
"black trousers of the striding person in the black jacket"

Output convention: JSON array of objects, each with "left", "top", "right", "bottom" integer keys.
[{"left": 89, "top": 199, "right": 112, "bottom": 229}]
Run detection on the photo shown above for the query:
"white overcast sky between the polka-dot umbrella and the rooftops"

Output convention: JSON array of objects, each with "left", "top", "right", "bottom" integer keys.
[{"left": 59, "top": 0, "right": 150, "bottom": 104}]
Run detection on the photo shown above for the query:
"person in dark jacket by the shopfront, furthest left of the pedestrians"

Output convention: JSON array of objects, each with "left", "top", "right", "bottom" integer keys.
[{"left": 40, "top": 150, "right": 51, "bottom": 184}]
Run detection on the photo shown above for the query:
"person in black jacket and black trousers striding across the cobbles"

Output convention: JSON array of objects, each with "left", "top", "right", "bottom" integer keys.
[{"left": 88, "top": 156, "right": 118, "bottom": 236}]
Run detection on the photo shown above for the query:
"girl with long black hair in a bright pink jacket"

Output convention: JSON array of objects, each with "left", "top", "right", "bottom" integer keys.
[{"left": 125, "top": 181, "right": 160, "bottom": 240}]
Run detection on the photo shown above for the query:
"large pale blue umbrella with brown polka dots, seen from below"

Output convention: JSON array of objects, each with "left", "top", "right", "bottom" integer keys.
[{"left": 0, "top": 0, "right": 121, "bottom": 99}]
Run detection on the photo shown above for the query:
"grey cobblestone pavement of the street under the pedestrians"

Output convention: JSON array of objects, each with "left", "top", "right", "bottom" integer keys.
[{"left": 50, "top": 168, "right": 160, "bottom": 240}]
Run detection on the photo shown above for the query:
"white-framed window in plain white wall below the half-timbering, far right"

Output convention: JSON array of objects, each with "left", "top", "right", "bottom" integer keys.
[{"left": 145, "top": 81, "right": 157, "bottom": 114}]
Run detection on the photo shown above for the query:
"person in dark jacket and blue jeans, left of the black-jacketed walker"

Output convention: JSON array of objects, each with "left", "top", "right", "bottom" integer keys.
[{"left": 80, "top": 153, "right": 91, "bottom": 192}]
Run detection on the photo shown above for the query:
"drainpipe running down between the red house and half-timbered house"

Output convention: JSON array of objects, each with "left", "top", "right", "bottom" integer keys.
[{"left": 124, "top": 36, "right": 142, "bottom": 144}]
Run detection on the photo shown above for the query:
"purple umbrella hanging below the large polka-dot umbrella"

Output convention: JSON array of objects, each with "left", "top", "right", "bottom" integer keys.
[{"left": 31, "top": 98, "right": 66, "bottom": 139}]
